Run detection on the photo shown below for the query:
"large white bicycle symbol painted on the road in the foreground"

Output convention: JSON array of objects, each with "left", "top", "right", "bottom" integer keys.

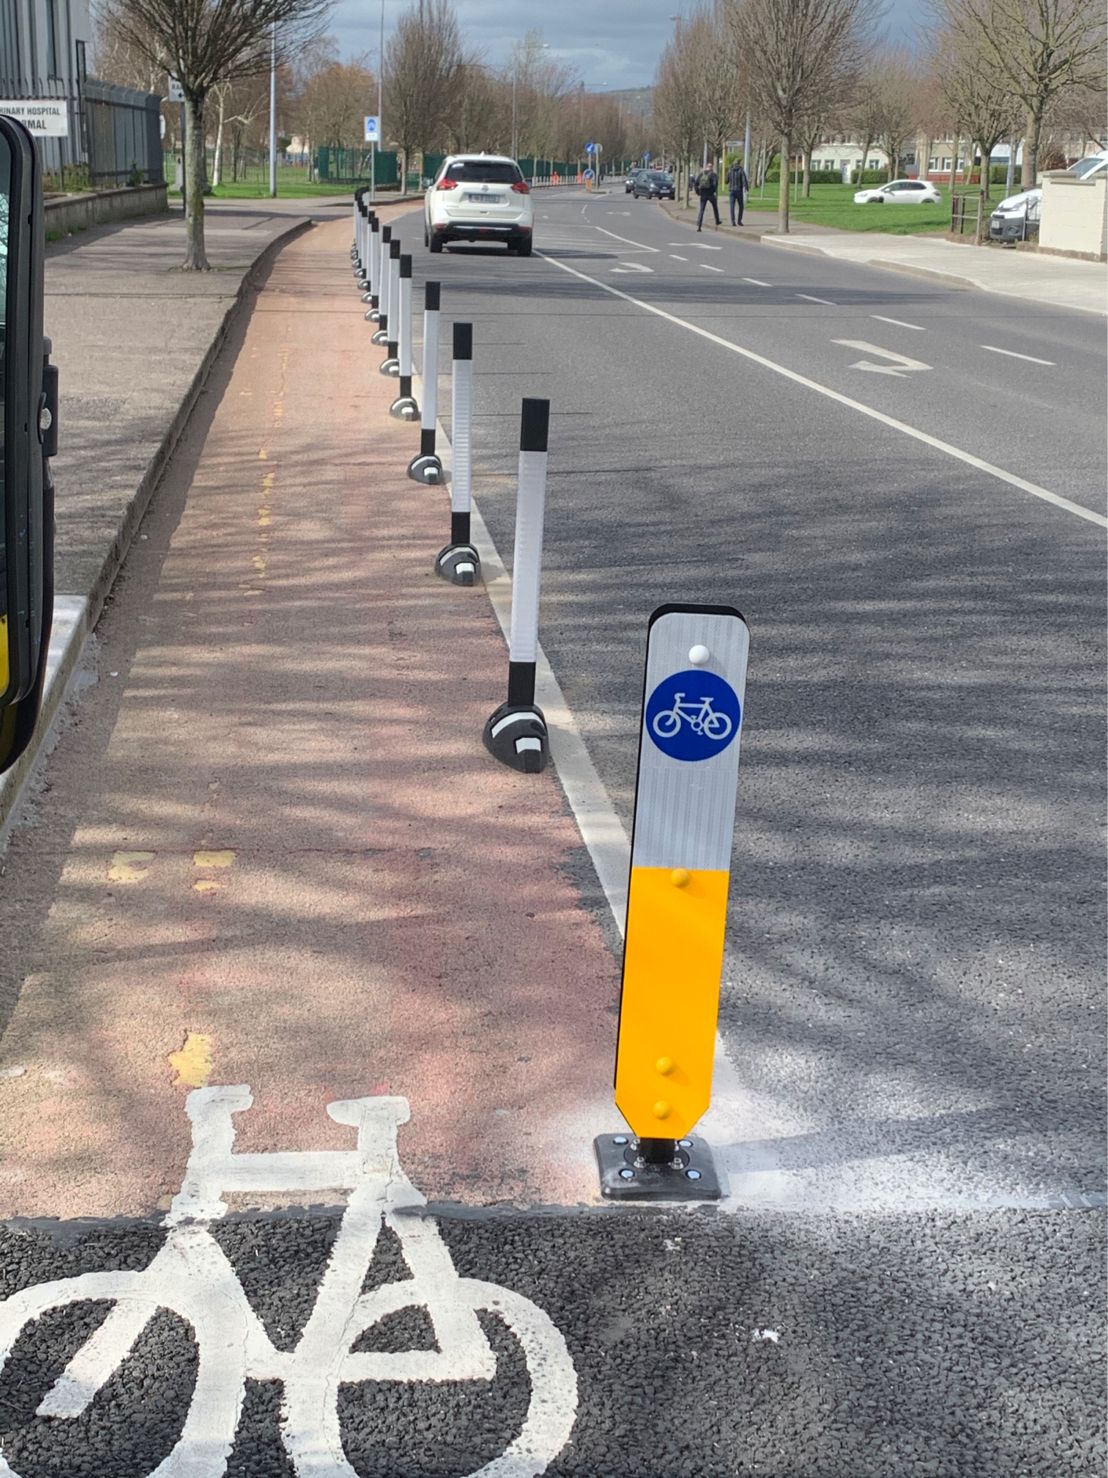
[{"left": 0, "top": 1086, "right": 578, "bottom": 1478}]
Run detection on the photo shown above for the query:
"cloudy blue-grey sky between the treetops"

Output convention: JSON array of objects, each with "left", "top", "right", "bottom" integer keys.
[{"left": 329, "top": 0, "right": 919, "bottom": 92}]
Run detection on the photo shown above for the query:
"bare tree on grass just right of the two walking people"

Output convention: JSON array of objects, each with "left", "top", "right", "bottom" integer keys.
[{"left": 728, "top": 0, "right": 878, "bottom": 232}]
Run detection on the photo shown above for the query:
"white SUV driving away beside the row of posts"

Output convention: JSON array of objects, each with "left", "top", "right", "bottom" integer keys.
[{"left": 424, "top": 154, "right": 535, "bottom": 257}]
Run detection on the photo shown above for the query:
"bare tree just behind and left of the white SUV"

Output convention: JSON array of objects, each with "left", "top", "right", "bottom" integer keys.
[{"left": 384, "top": 0, "right": 464, "bottom": 177}]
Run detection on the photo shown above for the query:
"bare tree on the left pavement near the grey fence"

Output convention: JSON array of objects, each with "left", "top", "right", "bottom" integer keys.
[{"left": 100, "top": 0, "right": 329, "bottom": 272}]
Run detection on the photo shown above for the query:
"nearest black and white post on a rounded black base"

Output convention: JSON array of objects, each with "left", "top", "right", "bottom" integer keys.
[{"left": 483, "top": 399, "right": 550, "bottom": 774}]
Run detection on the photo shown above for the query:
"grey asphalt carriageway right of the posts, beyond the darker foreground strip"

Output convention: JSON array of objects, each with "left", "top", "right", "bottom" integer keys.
[{"left": 399, "top": 195, "right": 1105, "bottom": 1208}]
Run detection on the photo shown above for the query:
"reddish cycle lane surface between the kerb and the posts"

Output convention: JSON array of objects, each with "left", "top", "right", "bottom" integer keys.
[{"left": 0, "top": 222, "right": 619, "bottom": 1218}]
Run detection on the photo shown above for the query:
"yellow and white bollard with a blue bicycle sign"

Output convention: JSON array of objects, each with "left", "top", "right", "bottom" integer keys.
[{"left": 595, "top": 605, "right": 749, "bottom": 1200}]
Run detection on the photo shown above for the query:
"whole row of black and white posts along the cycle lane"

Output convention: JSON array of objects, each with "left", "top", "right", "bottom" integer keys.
[{"left": 350, "top": 189, "right": 550, "bottom": 774}]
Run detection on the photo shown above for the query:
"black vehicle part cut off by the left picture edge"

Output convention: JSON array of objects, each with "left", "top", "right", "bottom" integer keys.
[{"left": 0, "top": 115, "right": 58, "bottom": 772}]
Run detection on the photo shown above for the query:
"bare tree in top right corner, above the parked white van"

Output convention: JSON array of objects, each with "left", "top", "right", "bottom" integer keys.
[{"left": 932, "top": 0, "right": 1105, "bottom": 189}]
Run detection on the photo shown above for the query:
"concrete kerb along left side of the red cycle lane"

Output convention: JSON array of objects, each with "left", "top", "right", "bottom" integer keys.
[{"left": 0, "top": 220, "right": 313, "bottom": 853}]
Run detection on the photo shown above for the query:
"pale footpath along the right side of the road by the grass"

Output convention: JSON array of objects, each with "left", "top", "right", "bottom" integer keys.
[{"left": 665, "top": 197, "right": 1108, "bottom": 313}]
